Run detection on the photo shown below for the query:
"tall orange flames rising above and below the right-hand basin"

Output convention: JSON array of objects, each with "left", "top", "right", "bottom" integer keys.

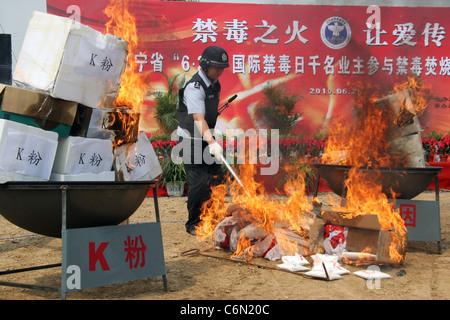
[{"left": 322, "top": 78, "right": 427, "bottom": 264}]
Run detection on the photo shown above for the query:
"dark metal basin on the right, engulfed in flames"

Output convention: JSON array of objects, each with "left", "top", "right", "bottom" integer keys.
[{"left": 314, "top": 164, "right": 442, "bottom": 199}]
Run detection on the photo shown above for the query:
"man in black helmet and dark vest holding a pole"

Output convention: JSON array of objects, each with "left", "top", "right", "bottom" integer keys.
[{"left": 177, "top": 46, "right": 229, "bottom": 235}]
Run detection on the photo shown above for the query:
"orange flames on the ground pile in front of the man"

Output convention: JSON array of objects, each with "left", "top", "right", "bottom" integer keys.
[{"left": 197, "top": 159, "right": 313, "bottom": 260}]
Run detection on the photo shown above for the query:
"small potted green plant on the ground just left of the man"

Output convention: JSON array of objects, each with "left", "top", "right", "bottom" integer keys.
[{"left": 160, "top": 158, "right": 186, "bottom": 197}]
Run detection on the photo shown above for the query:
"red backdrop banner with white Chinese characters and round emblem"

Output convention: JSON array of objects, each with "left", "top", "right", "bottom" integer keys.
[{"left": 47, "top": 0, "right": 450, "bottom": 139}]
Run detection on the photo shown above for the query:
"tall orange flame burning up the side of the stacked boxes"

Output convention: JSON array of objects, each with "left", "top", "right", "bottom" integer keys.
[{"left": 104, "top": 0, "right": 147, "bottom": 146}]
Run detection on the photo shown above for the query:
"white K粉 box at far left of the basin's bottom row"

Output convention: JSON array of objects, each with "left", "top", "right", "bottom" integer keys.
[{"left": 0, "top": 119, "right": 58, "bottom": 180}]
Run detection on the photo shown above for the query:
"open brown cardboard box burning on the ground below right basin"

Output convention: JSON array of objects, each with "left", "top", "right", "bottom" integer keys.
[{"left": 322, "top": 211, "right": 406, "bottom": 265}]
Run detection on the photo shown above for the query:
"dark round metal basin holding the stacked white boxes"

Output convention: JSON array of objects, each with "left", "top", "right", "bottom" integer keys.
[{"left": 0, "top": 181, "right": 154, "bottom": 238}]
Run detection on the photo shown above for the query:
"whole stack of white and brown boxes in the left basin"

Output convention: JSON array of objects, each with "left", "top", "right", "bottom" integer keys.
[{"left": 0, "top": 12, "right": 160, "bottom": 182}]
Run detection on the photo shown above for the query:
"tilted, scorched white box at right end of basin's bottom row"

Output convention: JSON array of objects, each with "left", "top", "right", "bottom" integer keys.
[{"left": 115, "top": 132, "right": 162, "bottom": 181}]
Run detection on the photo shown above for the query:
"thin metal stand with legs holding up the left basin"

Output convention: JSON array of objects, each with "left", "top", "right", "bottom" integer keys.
[{"left": 0, "top": 181, "right": 168, "bottom": 299}]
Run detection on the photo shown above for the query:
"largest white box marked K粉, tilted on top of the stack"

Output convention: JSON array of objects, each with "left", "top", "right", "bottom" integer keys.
[{"left": 13, "top": 11, "right": 128, "bottom": 108}]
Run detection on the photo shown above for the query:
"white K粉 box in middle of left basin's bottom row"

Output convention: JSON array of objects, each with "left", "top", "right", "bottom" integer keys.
[{"left": 52, "top": 136, "right": 113, "bottom": 174}]
